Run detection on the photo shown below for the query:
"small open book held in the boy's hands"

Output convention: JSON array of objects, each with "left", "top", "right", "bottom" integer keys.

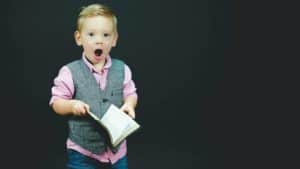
[{"left": 88, "top": 104, "right": 140, "bottom": 147}]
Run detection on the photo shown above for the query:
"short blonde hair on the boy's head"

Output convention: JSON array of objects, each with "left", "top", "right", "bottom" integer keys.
[{"left": 76, "top": 4, "right": 117, "bottom": 32}]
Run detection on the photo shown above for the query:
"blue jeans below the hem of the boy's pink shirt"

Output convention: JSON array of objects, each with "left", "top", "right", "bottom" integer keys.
[{"left": 67, "top": 149, "right": 128, "bottom": 169}]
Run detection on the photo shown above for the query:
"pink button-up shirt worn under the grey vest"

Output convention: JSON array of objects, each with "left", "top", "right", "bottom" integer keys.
[{"left": 49, "top": 56, "right": 137, "bottom": 164}]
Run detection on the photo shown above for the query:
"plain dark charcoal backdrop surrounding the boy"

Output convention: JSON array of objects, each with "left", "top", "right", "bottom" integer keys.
[{"left": 0, "top": 0, "right": 299, "bottom": 169}]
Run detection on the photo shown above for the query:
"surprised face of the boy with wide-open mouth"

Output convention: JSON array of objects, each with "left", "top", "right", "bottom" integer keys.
[{"left": 75, "top": 16, "right": 118, "bottom": 65}]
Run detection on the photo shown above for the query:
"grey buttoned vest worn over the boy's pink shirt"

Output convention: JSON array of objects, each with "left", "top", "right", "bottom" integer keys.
[{"left": 67, "top": 59, "right": 124, "bottom": 154}]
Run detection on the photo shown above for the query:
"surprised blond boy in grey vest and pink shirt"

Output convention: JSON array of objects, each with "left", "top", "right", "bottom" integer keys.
[{"left": 50, "top": 4, "right": 137, "bottom": 169}]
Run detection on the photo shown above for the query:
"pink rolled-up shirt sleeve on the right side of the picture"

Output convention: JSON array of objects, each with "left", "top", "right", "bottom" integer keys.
[{"left": 123, "top": 65, "right": 137, "bottom": 99}]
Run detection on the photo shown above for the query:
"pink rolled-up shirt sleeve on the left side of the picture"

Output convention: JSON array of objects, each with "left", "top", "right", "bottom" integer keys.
[{"left": 49, "top": 66, "right": 74, "bottom": 105}]
